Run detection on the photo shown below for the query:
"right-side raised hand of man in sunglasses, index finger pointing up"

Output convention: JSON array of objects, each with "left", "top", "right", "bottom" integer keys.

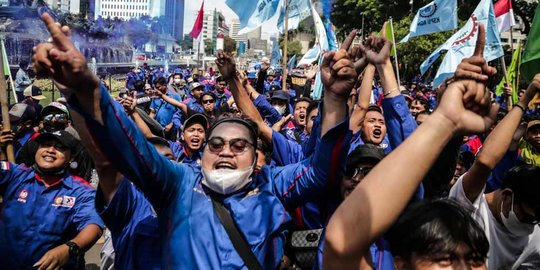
[{"left": 321, "top": 31, "right": 357, "bottom": 100}]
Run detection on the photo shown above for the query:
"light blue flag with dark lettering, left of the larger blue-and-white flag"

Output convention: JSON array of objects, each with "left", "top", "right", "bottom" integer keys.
[{"left": 400, "top": 0, "right": 458, "bottom": 42}]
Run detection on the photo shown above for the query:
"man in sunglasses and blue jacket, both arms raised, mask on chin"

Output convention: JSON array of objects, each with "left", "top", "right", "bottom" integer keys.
[{"left": 33, "top": 14, "right": 357, "bottom": 269}]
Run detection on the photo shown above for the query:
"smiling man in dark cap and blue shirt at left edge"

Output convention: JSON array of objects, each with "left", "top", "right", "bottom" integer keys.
[{"left": 0, "top": 130, "right": 103, "bottom": 269}]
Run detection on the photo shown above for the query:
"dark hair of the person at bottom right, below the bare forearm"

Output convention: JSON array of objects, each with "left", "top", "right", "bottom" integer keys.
[{"left": 386, "top": 199, "right": 489, "bottom": 261}]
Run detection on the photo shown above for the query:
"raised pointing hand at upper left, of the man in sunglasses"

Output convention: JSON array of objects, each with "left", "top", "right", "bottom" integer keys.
[{"left": 32, "top": 13, "right": 99, "bottom": 93}]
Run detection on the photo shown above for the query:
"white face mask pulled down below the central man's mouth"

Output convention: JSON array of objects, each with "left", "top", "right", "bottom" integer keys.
[{"left": 202, "top": 165, "right": 253, "bottom": 195}]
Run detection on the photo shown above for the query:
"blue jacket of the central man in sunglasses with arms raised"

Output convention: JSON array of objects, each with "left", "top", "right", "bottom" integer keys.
[{"left": 69, "top": 85, "right": 350, "bottom": 269}]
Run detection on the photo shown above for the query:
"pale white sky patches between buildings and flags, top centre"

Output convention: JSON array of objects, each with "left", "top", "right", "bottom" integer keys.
[{"left": 184, "top": 0, "right": 278, "bottom": 39}]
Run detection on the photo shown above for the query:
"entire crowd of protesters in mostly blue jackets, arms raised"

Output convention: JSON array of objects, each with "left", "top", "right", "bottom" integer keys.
[{"left": 0, "top": 14, "right": 540, "bottom": 269}]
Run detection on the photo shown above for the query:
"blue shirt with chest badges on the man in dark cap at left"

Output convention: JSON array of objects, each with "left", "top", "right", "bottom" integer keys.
[{"left": 0, "top": 161, "right": 103, "bottom": 269}]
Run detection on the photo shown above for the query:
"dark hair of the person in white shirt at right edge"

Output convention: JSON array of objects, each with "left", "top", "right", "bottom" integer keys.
[{"left": 501, "top": 164, "right": 540, "bottom": 211}]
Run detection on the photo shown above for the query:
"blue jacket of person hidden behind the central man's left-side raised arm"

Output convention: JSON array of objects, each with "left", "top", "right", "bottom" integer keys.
[{"left": 96, "top": 178, "right": 161, "bottom": 269}]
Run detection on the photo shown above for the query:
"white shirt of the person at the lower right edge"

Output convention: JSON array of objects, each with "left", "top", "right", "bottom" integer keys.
[{"left": 449, "top": 174, "right": 529, "bottom": 270}]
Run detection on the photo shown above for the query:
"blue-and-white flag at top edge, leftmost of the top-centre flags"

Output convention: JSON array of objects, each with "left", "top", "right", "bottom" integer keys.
[{"left": 225, "top": 0, "right": 283, "bottom": 35}]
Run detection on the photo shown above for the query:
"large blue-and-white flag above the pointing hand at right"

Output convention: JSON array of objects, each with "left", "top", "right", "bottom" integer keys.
[{"left": 420, "top": 0, "right": 504, "bottom": 87}]
